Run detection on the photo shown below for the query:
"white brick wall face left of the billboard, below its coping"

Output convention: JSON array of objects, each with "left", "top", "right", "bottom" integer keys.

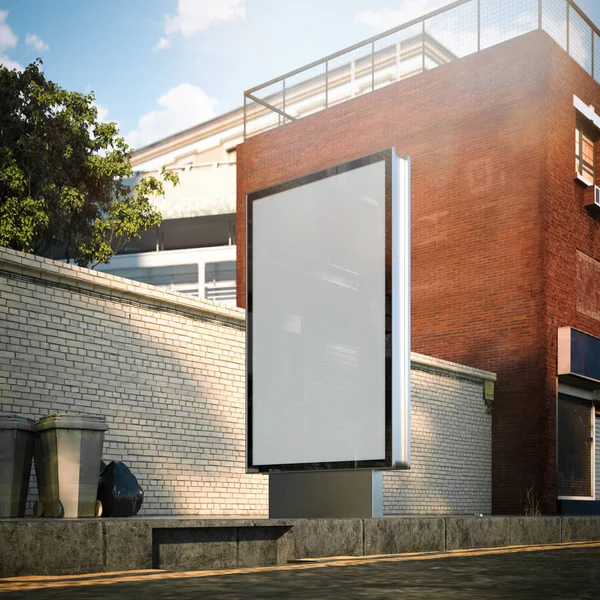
[{"left": 0, "top": 277, "right": 268, "bottom": 516}]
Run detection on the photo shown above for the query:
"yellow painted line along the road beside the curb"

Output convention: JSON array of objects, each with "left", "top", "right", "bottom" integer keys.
[{"left": 0, "top": 542, "right": 600, "bottom": 592}]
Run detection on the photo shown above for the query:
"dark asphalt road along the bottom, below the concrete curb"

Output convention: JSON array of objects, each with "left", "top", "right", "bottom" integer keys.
[{"left": 0, "top": 543, "right": 600, "bottom": 600}]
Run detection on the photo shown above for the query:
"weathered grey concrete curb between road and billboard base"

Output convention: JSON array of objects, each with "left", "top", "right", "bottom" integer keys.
[{"left": 0, "top": 516, "right": 600, "bottom": 577}]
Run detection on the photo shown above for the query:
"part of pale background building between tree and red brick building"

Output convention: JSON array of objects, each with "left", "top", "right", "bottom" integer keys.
[{"left": 97, "top": 109, "right": 244, "bottom": 304}]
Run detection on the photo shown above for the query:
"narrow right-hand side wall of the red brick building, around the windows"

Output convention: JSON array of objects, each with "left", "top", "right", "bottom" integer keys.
[{"left": 540, "top": 44, "right": 600, "bottom": 508}]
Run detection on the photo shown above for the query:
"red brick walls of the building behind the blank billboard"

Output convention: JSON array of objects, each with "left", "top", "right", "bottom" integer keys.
[{"left": 237, "top": 2, "right": 600, "bottom": 513}]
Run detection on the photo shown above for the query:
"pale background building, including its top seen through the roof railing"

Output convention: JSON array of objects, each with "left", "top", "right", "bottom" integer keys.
[{"left": 97, "top": 30, "right": 456, "bottom": 304}]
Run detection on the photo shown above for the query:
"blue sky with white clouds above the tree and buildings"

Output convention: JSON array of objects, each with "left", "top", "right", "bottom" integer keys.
[{"left": 0, "top": 0, "right": 600, "bottom": 148}]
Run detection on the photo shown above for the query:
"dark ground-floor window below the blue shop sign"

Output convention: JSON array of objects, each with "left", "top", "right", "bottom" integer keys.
[{"left": 557, "top": 394, "right": 594, "bottom": 497}]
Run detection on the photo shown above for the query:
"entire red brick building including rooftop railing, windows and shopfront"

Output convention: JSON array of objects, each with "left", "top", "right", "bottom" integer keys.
[{"left": 236, "top": 0, "right": 600, "bottom": 513}]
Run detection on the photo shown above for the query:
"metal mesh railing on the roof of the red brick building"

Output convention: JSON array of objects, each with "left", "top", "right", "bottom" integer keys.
[{"left": 244, "top": 0, "right": 600, "bottom": 138}]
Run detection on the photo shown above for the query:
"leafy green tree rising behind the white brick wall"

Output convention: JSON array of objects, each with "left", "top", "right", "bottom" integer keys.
[{"left": 0, "top": 59, "right": 179, "bottom": 266}]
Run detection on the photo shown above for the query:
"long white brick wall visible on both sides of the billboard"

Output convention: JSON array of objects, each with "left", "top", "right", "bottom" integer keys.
[{"left": 0, "top": 248, "right": 493, "bottom": 516}]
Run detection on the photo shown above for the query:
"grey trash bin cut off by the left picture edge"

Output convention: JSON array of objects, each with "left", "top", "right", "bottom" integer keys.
[{"left": 0, "top": 415, "right": 35, "bottom": 517}]
